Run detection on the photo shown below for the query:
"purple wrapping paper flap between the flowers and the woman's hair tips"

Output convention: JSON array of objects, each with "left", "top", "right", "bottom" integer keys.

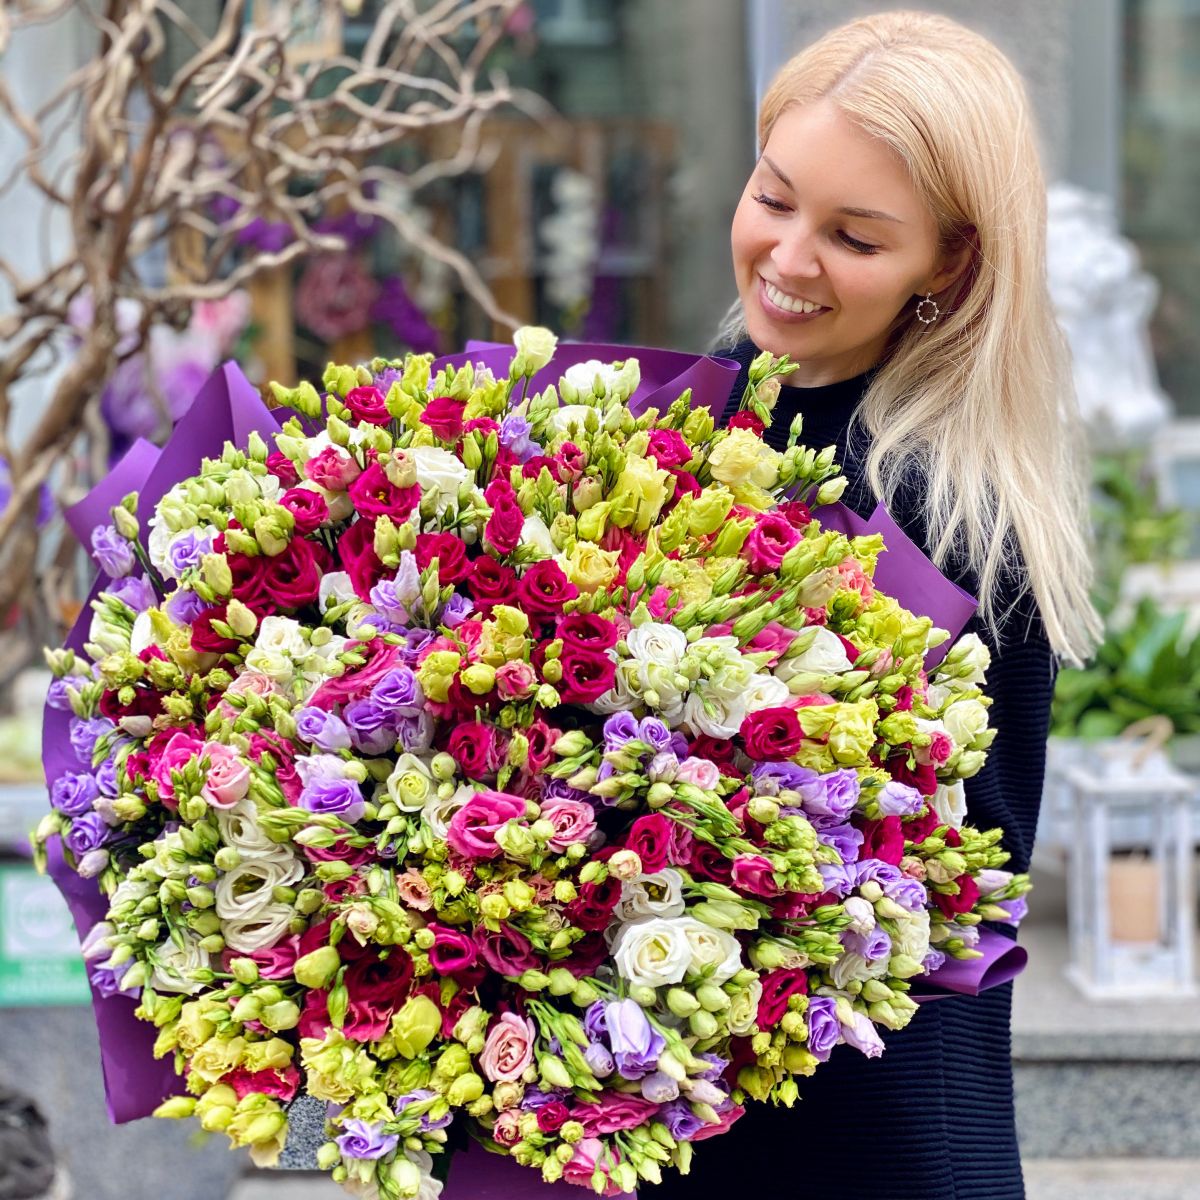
[{"left": 814, "top": 502, "right": 979, "bottom": 671}]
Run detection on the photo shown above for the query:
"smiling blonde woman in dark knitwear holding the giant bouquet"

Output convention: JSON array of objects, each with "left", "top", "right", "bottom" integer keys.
[{"left": 654, "top": 13, "right": 1099, "bottom": 1200}]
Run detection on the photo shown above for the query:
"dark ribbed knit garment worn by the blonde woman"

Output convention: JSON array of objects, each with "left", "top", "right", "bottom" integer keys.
[{"left": 644, "top": 342, "right": 1055, "bottom": 1200}]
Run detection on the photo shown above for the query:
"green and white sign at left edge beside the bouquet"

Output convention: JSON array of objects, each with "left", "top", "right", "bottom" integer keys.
[{"left": 0, "top": 864, "right": 91, "bottom": 1008}]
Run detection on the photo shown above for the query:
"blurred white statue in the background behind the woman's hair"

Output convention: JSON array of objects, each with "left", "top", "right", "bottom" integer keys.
[{"left": 1046, "top": 184, "right": 1171, "bottom": 443}]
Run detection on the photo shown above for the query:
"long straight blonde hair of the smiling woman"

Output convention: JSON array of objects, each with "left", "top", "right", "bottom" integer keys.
[{"left": 719, "top": 12, "right": 1102, "bottom": 664}]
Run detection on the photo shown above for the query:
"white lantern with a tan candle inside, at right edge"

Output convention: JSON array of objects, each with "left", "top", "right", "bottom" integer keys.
[{"left": 1063, "top": 740, "right": 1200, "bottom": 1000}]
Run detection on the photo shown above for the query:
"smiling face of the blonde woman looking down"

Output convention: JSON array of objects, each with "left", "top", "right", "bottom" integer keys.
[{"left": 732, "top": 100, "right": 965, "bottom": 386}]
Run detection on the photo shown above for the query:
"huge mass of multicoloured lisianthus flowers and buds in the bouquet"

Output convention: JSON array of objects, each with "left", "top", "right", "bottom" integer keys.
[{"left": 38, "top": 329, "right": 1027, "bottom": 1200}]
